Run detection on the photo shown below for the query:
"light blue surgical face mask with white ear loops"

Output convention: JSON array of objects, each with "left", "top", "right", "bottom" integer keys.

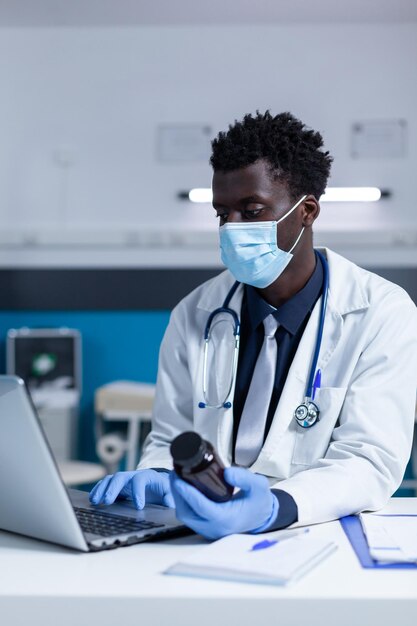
[{"left": 219, "top": 196, "right": 307, "bottom": 289}]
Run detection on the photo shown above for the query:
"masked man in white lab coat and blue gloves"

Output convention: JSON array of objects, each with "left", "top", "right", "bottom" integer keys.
[{"left": 90, "top": 111, "right": 417, "bottom": 538}]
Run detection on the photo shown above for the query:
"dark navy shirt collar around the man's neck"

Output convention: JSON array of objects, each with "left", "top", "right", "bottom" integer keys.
[{"left": 245, "top": 255, "right": 323, "bottom": 335}]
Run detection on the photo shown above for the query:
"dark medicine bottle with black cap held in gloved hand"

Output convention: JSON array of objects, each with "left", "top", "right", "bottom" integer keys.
[{"left": 171, "top": 431, "right": 233, "bottom": 502}]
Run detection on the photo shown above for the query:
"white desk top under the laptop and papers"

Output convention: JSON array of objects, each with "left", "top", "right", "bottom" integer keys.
[{"left": 0, "top": 498, "right": 417, "bottom": 626}]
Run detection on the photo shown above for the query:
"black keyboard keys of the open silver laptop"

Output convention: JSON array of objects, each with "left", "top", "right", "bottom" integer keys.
[{"left": 74, "top": 507, "right": 164, "bottom": 537}]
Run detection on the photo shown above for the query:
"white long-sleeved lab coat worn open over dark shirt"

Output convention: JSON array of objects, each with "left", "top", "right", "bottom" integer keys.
[{"left": 139, "top": 249, "right": 417, "bottom": 524}]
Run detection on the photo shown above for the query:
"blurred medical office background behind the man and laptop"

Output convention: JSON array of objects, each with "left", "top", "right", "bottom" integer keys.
[{"left": 0, "top": 0, "right": 417, "bottom": 620}]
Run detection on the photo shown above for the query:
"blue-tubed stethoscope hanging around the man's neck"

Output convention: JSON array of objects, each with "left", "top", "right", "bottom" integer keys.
[{"left": 198, "top": 250, "right": 329, "bottom": 428}]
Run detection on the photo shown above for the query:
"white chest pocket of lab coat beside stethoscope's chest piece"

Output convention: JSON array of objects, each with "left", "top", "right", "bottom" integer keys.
[{"left": 292, "top": 387, "right": 347, "bottom": 466}]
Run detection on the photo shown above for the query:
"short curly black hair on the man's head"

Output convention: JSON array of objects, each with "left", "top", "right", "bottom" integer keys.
[{"left": 210, "top": 110, "right": 333, "bottom": 199}]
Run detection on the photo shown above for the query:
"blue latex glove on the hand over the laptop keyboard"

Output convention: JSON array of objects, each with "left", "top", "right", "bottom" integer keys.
[{"left": 90, "top": 469, "right": 175, "bottom": 509}]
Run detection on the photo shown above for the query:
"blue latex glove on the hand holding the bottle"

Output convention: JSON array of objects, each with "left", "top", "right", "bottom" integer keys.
[{"left": 170, "top": 467, "right": 279, "bottom": 539}]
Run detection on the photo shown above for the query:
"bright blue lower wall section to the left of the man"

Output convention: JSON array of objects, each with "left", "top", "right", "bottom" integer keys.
[{"left": 0, "top": 311, "right": 170, "bottom": 460}]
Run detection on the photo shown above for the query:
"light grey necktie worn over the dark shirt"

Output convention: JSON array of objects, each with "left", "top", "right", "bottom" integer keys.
[{"left": 235, "top": 313, "right": 278, "bottom": 467}]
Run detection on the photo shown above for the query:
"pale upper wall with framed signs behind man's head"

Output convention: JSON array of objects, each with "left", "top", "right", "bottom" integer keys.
[{"left": 0, "top": 23, "right": 417, "bottom": 264}]
